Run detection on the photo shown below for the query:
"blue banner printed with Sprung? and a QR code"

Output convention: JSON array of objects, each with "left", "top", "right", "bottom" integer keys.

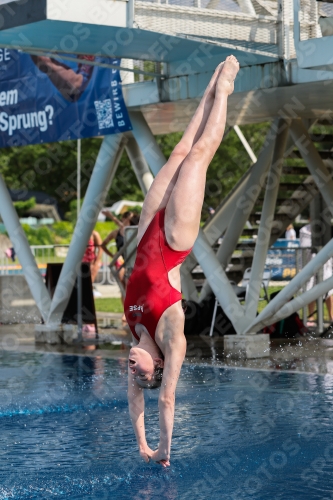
[{"left": 0, "top": 49, "right": 132, "bottom": 147}]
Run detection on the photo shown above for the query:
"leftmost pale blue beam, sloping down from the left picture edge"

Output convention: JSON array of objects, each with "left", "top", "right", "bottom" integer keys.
[{"left": 0, "top": 175, "right": 51, "bottom": 321}]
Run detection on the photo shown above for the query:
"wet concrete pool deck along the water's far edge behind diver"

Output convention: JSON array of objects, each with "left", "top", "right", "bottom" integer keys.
[{"left": 0, "top": 313, "right": 333, "bottom": 374}]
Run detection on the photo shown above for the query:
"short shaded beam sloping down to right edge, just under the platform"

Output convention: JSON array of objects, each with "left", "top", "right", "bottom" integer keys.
[{"left": 290, "top": 120, "right": 333, "bottom": 214}]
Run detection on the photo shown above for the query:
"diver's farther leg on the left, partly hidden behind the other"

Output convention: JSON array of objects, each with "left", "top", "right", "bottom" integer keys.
[{"left": 138, "top": 63, "right": 224, "bottom": 241}]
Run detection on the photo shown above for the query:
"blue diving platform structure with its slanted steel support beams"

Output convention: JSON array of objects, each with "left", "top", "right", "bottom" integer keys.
[{"left": 0, "top": 0, "right": 333, "bottom": 355}]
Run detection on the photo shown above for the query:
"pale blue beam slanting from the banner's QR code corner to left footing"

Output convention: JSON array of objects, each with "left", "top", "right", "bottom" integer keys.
[{"left": 47, "top": 134, "right": 124, "bottom": 325}]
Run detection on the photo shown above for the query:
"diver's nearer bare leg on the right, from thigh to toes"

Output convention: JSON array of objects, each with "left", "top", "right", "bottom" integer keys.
[{"left": 165, "top": 56, "right": 239, "bottom": 250}]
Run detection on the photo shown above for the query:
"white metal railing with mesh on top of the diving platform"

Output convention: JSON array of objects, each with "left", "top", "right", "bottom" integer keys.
[{"left": 134, "top": 0, "right": 333, "bottom": 63}]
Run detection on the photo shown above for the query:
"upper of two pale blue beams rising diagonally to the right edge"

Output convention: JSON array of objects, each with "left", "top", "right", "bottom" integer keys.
[{"left": 244, "top": 239, "right": 333, "bottom": 333}]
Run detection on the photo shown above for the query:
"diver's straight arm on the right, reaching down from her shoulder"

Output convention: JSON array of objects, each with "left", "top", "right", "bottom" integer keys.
[{"left": 152, "top": 335, "right": 186, "bottom": 465}]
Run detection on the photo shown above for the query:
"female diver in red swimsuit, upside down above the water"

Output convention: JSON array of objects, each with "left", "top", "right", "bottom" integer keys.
[{"left": 125, "top": 56, "right": 239, "bottom": 467}]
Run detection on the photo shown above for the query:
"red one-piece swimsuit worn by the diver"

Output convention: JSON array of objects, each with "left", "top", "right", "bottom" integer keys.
[{"left": 124, "top": 209, "right": 192, "bottom": 340}]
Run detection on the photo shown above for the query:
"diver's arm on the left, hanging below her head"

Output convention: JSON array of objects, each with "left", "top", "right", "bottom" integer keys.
[{"left": 127, "top": 370, "right": 153, "bottom": 462}]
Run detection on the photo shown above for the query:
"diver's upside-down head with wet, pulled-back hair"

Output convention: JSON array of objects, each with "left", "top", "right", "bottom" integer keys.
[{"left": 128, "top": 346, "right": 164, "bottom": 389}]
